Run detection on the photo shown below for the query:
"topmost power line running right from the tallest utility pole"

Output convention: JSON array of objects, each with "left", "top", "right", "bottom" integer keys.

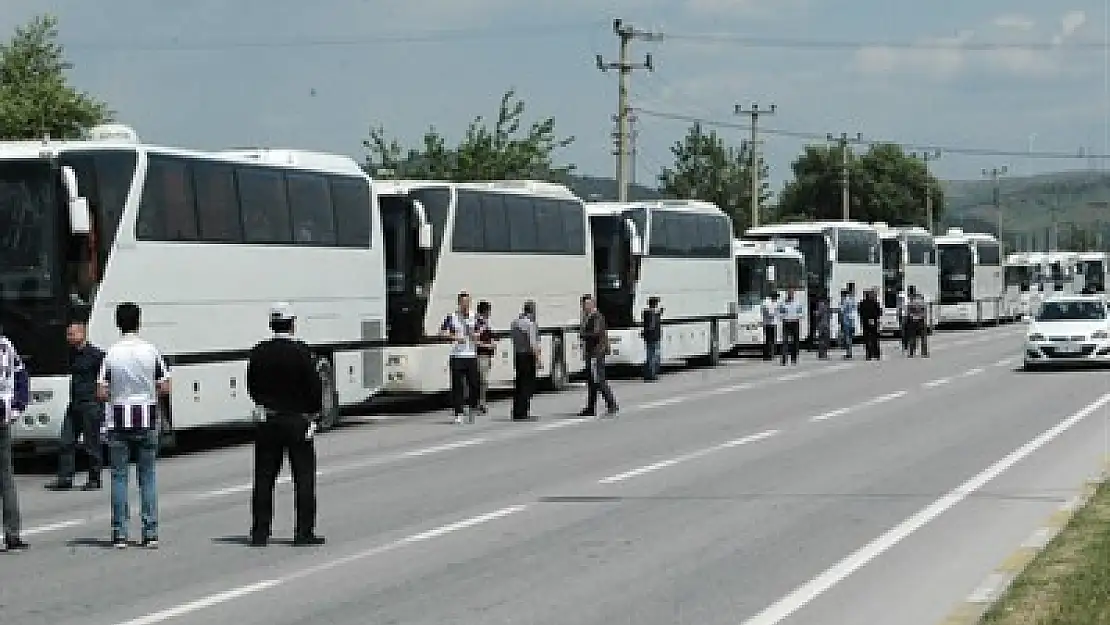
[{"left": 666, "top": 33, "right": 1106, "bottom": 52}]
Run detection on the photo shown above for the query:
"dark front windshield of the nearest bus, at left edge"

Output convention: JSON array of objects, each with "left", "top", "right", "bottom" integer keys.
[{"left": 0, "top": 161, "right": 61, "bottom": 301}]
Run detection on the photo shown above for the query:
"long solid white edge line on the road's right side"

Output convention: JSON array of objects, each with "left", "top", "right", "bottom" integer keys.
[{"left": 743, "top": 393, "right": 1110, "bottom": 625}]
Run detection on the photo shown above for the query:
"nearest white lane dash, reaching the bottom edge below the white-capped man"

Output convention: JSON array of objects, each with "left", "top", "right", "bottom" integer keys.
[{"left": 118, "top": 505, "right": 528, "bottom": 625}]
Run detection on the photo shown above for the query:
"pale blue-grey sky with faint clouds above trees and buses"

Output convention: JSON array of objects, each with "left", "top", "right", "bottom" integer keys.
[{"left": 0, "top": 0, "right": 1110, "bottom": 190}]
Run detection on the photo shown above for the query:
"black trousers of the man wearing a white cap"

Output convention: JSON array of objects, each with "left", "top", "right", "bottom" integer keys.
[{"left": 251, "top": 415, "right": 316, "bottom": 538}]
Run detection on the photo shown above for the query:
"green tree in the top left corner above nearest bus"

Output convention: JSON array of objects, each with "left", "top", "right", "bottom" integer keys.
[{"left": 0, "top": 16, "right": 113, "bottom": 140}]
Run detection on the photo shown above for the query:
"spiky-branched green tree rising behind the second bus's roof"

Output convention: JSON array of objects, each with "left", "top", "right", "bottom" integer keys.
[{"left": 363, "top": 90, "right": 574, "bottom": 181}]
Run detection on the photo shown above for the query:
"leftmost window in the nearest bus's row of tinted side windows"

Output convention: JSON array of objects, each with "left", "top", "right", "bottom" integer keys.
[{"left": 135, "top": 155, "right": 196, "bottom": 241}]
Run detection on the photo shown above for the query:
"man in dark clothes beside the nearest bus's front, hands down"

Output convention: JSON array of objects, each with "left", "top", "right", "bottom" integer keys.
[{"left": 47, "top": 320, "right": 104, "bottom": 491}]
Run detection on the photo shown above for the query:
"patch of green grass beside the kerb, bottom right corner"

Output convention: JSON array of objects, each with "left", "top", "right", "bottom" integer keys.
[{"left": 980, "top": 483, "right": 1110, "bottom": 625}]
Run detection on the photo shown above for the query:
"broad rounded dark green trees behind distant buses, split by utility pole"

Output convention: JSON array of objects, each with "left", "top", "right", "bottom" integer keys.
[{"left": 778, "top": 143, "right": 945, "bottom": 226}]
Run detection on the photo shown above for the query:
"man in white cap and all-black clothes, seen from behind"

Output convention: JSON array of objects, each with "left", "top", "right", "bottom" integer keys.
[{"left": 246, "top": 302, "right": 324, "bottom": 547}]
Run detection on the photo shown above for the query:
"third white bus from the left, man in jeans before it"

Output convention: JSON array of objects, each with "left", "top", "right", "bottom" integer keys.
[{"left": 586, "top": 200, "right": 737, "bottom": 366}]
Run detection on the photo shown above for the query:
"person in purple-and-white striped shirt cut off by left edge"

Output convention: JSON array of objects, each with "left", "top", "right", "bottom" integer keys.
[{"left": 0, "top": 332, "right": 31, "bottom": 552}]
